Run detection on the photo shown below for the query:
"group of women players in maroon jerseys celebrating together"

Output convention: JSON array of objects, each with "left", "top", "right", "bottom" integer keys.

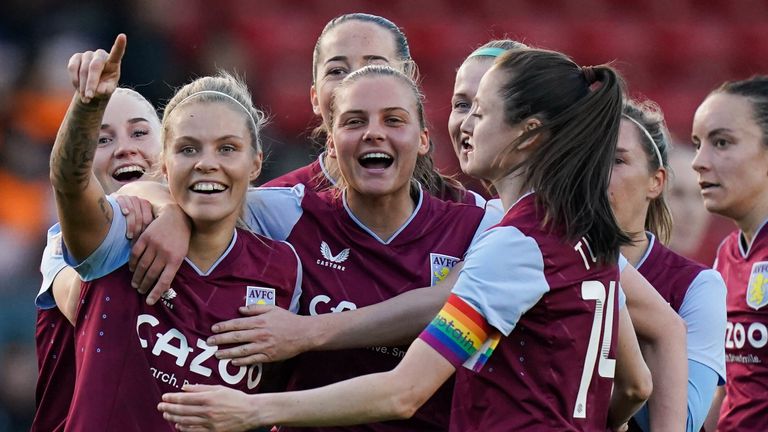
[{"left": 32, "top": 13, "right": 768, "bottom": 432}]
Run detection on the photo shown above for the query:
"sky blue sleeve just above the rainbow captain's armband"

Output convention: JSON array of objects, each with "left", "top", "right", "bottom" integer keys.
[{"left": 453, "top": 226, "right": 549, "bottom": 336}]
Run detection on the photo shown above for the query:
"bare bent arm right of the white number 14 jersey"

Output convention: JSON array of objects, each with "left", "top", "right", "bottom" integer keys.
[{"left": 621, "top": 265, "right": 688, "bottom": 431}]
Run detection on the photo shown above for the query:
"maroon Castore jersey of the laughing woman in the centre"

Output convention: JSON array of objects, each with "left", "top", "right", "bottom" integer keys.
[{"left": 281, "top": 191, "right": 484, "bottom": 431}]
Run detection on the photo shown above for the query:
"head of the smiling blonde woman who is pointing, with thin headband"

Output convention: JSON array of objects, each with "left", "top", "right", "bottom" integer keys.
[{"left": 162, "top": 86, "right": 264, "bottom": 231}]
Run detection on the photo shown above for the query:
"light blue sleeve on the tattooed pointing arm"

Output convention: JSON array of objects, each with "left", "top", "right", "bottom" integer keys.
[{"left": 62, "top": 196, "right": 131, "bottom": 282}]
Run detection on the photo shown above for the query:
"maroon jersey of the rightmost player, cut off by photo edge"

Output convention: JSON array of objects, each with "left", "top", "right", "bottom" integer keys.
[{"left": 715, "top": 224, "right": 768, "bottom": 431}]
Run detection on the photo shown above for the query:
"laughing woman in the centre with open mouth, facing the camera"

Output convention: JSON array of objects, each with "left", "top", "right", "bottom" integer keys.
[{"left": 228, "top": 65, "right": 500, "bottom": 431}]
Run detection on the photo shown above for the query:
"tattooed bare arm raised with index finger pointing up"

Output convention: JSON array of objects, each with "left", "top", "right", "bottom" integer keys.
[{"left": 50, "top": 34, "right": 126, "bottom": 260}]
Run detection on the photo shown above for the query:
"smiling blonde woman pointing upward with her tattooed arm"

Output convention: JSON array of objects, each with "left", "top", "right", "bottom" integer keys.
[{"left": 45, "top": 35, "right": 301, "bottom": 431}]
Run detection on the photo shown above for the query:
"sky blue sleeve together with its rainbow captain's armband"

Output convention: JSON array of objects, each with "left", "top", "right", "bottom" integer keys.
[{"left": 419, "top": 226, "right": 549, "bottom": 371}]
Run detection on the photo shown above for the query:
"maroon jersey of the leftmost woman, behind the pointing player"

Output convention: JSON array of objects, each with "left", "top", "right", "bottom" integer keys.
[{"left": 30, "top": 307, "right": 75, "bottom": 432}]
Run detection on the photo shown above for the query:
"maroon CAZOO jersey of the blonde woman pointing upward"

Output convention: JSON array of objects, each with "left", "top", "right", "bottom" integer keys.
[{"left": 66, "top": 230, "right": 300, "bottom": 431}]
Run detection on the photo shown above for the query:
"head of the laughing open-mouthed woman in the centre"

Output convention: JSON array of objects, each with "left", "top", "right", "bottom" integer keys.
[{"left": 328, "top": 66, "right": 429, "bottom": 208}]
